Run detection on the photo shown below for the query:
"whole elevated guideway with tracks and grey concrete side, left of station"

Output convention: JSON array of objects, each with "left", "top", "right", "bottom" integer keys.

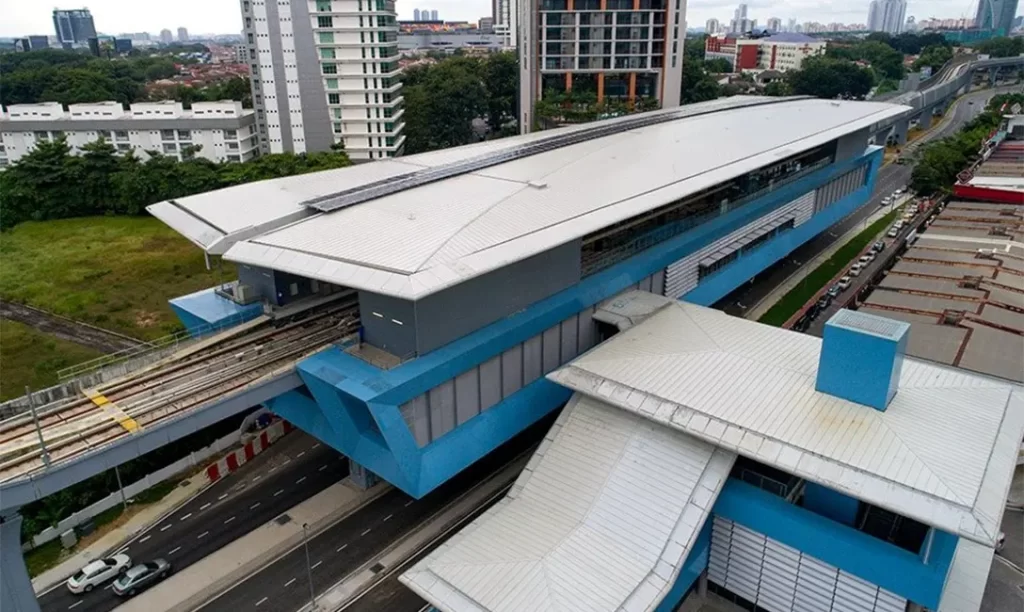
[{"left": 0, "top": 294, "right": 359, "bottom": 513}]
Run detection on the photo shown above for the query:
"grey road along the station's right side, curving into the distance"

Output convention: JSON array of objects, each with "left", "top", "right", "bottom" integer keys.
[{"left": 715, "top": 86, "right": 1020, "bottom": 316}]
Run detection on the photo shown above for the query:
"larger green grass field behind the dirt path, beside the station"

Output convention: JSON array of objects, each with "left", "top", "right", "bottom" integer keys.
[{"left": 0, "top": 217, "right": 234, "bottom": 339}]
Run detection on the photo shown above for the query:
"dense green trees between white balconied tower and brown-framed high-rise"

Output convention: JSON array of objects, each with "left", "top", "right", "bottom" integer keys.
[{"left": 401, "top": 52, "right": 519, "bottom": 154}]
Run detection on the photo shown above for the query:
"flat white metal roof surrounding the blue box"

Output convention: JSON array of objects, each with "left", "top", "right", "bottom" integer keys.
[{"left": 548, "top": 292, "right": 1024, "bottom": 547}]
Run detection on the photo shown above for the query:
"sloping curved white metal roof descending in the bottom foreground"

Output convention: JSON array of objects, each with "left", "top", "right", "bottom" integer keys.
[{"left": 400, "top": 394, "right": 736, "bottom": 612}]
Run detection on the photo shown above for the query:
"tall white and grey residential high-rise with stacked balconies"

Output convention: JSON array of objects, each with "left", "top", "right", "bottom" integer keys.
[{"left": 241, "top": 0, "right": 406, "bottom": 161}]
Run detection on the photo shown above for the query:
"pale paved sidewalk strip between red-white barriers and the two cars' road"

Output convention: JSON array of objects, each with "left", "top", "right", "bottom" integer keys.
[{"left": 32, "top": 474, "right": 210, "bottom": 595}]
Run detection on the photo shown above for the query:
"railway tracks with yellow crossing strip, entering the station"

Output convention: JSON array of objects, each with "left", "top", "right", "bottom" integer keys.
[{"left": 0, "top": 295, "right": 359, "bottom": 489}]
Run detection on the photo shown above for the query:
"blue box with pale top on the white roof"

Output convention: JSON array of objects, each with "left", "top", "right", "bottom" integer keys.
[{"left": 814, "top": 309, "right": 910, "bottom": 411}]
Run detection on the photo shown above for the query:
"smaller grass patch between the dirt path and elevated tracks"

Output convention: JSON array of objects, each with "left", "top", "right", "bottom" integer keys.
[{"left": 0, "top": 321, "right": 101, "bottom": 401}]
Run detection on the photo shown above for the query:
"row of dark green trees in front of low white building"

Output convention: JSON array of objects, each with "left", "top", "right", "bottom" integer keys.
[{"left": 0, "top": 139, "right": 350, "bottom": 229}]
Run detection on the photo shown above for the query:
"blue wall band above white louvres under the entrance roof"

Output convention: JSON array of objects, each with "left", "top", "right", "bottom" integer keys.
[{"left": 712, "top": 479, "right": 956, "bottom": 610}]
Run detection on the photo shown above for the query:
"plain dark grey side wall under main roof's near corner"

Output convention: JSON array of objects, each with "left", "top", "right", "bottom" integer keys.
[{"left": 416, "top": 241, "right": 580, "bottom": 355}]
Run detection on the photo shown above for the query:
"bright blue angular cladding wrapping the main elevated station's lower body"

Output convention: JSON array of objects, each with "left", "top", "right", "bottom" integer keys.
[{"left": 270, "top": 147, "right": 882, "bottom": 496}]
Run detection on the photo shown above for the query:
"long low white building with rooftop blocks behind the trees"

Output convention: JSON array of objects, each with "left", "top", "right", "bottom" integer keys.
[{"left": 0, "top": 100, "right": 259, "bottom": 168}]
